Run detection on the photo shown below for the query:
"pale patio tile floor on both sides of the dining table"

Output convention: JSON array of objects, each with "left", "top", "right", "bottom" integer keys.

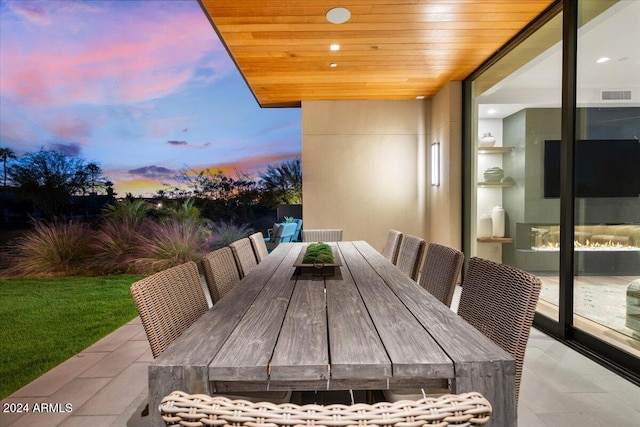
[{"left": 0, "top": 292, "right": 640, "bottom": 427}]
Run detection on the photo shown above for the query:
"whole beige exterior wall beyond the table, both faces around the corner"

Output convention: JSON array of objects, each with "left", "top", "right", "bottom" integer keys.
[{"left": 302, "top": 82, "right": 462, "bottom": 254}]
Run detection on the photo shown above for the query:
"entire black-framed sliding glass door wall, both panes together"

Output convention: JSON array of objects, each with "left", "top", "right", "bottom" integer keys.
[{"left": 464, "top": 0, "right": 640, "bottom": 382}]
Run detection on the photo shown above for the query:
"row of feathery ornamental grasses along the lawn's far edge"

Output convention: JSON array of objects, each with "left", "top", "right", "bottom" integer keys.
[{"left": 0, "top": 200, "right": 225, "bottom": 277}]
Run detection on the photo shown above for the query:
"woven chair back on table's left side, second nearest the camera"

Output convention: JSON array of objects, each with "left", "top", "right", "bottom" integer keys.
[{"left": 202, "top": 246, "right": 240, "bottom": 304}]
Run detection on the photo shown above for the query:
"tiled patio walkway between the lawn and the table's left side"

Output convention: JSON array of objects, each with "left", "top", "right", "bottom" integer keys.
[{"left": 0, "top": 318, "right": 153, "bottom": 427}]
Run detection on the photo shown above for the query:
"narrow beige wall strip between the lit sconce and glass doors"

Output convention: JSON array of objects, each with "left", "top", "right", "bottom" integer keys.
[{"left": 428, "top": 82, "right": 462, "bottom": 249}]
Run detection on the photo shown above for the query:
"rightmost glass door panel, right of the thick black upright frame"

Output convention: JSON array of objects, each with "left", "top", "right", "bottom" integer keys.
[{"left": 572, "top": 0, "right": 640, "bottom": 357}]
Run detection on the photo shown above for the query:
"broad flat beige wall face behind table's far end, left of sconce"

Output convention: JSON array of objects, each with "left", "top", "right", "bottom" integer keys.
[{"left": 302, "top": 100, "right": 431, "bottom": 250}]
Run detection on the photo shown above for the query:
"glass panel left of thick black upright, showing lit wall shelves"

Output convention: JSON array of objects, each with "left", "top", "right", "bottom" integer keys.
[{"left": 470, "top": 6, "right": 562, "bottom": 321}]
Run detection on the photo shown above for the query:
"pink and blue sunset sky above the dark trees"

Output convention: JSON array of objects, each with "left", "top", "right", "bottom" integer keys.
[{"left": 0, "top": 0, "right": 301, "bottom": 196}]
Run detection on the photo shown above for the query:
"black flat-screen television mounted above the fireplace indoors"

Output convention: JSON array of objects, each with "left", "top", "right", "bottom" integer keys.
[{"left": 544, "top": 139, "right": 640, "bottom": 198}]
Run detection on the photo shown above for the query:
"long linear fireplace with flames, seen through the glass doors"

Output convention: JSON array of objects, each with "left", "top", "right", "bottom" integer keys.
[{"left": 515, "top": 223, "right": 640, "bottom": 276}]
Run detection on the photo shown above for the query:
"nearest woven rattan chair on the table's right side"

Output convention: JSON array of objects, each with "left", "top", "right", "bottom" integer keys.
[{"left": 458, "top": 257, "right": 540, "bottom": 397}]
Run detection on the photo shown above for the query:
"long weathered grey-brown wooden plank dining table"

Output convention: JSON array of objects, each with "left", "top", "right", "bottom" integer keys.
[{"left": 149, "top": 241, "right": 517, "bottom": 427}]
